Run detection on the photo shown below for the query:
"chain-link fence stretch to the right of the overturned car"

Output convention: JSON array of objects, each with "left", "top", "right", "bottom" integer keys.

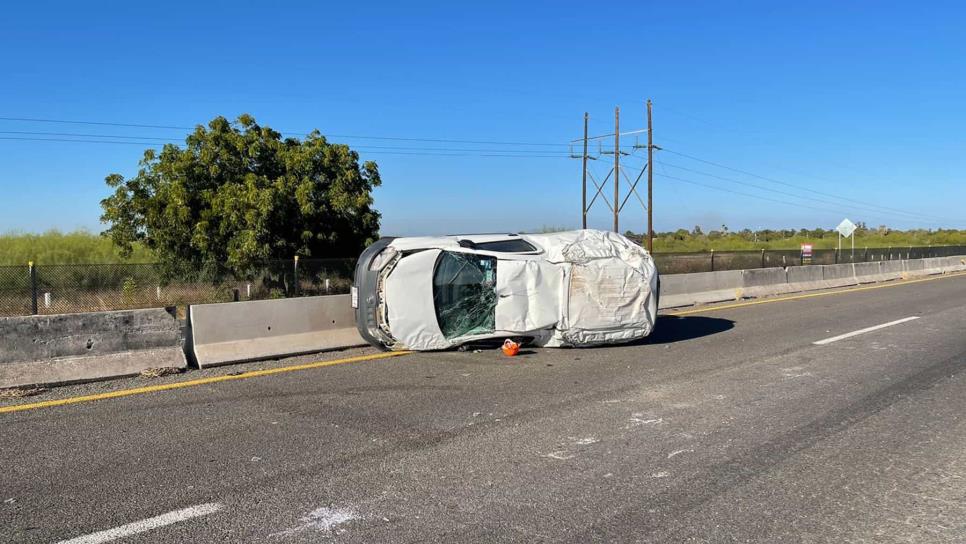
[{"left": 654, "top": 246, "right": 966, "bottom": 274}]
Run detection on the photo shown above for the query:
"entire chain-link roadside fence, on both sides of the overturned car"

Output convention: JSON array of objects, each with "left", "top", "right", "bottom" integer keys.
[{"left": 0, "top": 246, "right": 966, "bottom": 316}]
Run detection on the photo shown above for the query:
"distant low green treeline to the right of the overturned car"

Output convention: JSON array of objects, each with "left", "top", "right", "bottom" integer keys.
[{"left": 625, "top": 223, "right": 966, "bottom": 253}]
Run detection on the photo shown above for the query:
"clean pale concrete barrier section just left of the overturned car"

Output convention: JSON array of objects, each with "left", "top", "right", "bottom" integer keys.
[{"left": 189, "top": 295, "right": 366, "bottom": 368}]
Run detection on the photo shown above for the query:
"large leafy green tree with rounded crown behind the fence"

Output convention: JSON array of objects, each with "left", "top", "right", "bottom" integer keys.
[{"left": 101, "top": 115, "right": 381, "bottom": 277}]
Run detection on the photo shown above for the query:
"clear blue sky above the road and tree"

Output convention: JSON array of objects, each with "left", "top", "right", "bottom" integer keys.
[{"left": 0, "top": 1, "right": 966, "bottom": 235}]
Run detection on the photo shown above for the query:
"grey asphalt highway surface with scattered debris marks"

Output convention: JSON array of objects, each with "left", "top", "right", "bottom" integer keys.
[{"left": 0, "top": 276, "right": 966, "bottom": 544}]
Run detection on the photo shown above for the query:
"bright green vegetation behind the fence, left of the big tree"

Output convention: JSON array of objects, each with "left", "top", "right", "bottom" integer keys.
[{"left": 0, "top": 230, "right": 156, "bottom": 265}]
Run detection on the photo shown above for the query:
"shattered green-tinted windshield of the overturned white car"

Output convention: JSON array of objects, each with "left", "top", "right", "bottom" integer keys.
[{"left": 433, "top": 251, "right": 497, "bottom": 338}]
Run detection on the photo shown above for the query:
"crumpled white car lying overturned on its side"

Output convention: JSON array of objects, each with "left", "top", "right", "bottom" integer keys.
[{"left": 352, "top": 230, "right": 658, "bottom": 350}]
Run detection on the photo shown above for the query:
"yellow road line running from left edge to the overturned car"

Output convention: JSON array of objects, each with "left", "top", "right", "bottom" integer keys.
[{"left": 0, "top": 351, "right": 409, "bottom": 414}]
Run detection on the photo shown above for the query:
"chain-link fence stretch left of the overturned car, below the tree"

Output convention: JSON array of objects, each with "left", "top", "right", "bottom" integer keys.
[{"left": 0, "top": 259, "right": 355, "bottom": 316}]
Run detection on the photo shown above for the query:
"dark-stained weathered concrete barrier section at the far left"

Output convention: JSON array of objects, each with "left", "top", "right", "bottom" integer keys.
[{"left": 0, "top": 308, "right": 186, "bottom": 388}]
